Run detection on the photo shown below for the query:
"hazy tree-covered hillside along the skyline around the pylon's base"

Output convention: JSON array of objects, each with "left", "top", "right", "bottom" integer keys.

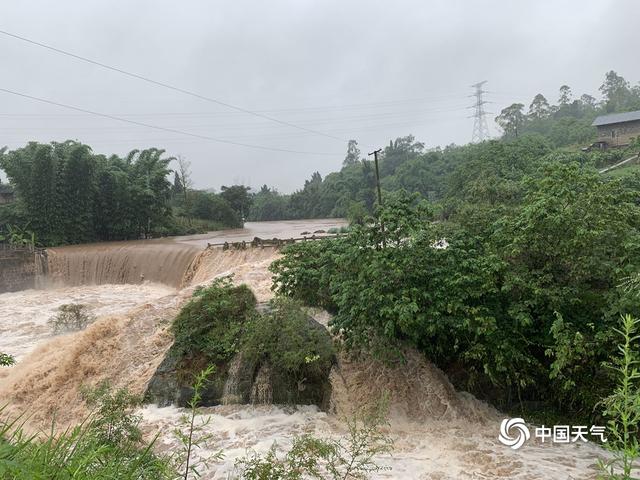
[{"left": 249, "top": 71, "right": 640, "bottom": 220}]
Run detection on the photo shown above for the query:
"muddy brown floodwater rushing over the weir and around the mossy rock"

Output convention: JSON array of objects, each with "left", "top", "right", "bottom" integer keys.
[{"left": 0, "top": 220, "right": 602, "bottom": 480}]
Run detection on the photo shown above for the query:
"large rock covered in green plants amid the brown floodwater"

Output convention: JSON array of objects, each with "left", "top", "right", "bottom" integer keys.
[{"left": 145, "top": 280, "right": 335, "bottom": 408}]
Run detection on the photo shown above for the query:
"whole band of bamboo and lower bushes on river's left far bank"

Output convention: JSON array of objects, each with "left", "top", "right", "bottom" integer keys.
[{"left": 0, "top": 141, "right": 241, "bottom": 246}]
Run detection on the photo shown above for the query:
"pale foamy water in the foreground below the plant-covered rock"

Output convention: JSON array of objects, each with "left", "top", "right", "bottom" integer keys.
[{"left": 139, "top": 405, "right": 604, "bottom": 480}]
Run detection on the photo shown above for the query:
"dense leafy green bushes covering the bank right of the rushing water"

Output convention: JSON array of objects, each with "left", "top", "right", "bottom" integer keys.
[{"left": 272, "top": 140, "right": 640, "bottom": 416}]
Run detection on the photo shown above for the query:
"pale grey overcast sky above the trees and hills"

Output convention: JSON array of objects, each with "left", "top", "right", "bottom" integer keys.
[{"left": 0, "top": 0, "right": 640, "bottom": 192}]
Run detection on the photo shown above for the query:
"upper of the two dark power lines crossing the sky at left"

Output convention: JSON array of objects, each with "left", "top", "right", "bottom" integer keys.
[{"left": 0, "top": 30, "right": 347, "bottom": 142}]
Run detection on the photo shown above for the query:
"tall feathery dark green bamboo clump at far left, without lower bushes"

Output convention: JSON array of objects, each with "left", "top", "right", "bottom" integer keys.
[{"left": 0, "top": 141, "right": 186, "bottom": 245}]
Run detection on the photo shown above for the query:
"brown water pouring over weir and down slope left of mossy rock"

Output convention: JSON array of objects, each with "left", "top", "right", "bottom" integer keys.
[{"left": 0, "top": 240, "right": 288, "bottom": 425}]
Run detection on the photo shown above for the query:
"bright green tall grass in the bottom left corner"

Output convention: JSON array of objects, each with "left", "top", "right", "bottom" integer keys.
[{"left": 0, "top": 388, "right": 176, "bottom": 480}]
